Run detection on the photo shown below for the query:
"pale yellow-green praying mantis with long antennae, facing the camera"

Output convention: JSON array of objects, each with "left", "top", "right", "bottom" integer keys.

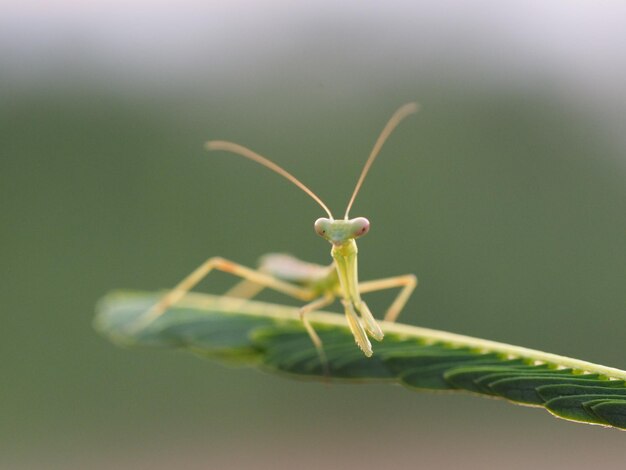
[{"left": 139, "top": 103, "right": 418, "bottom": 363}]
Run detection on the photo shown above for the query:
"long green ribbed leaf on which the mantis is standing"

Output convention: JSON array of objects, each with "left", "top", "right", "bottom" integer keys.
[{"left": 94, "top": 292, "right": 626, "bottom": 429}]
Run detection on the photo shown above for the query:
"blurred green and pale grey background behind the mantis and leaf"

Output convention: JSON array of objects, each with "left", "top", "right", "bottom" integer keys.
[{"left": 0, "top": 0, "right": 626, "bottom": 469}]
